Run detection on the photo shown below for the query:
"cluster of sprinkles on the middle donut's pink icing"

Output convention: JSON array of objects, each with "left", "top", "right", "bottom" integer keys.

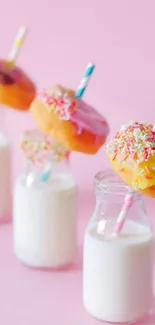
[{"left": 38, "top": 90, "right": 77, "bottom": 120}]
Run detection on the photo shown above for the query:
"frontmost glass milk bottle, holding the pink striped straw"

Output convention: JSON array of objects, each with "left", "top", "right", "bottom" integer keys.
[{"left": 83, "top": 171, "right": 154, "bottom": 323}]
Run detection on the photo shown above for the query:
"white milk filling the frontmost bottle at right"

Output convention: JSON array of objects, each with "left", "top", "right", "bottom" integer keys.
[{"left": 83, "top": 221, "right": 153, "bottom": 322}]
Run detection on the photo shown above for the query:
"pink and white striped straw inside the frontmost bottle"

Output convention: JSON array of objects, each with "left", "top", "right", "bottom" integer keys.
[{"left": 114, "top": 191, "right": 134, "bottom": 234}]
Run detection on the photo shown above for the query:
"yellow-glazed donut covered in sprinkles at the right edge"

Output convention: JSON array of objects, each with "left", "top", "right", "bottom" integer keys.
[{"left": 106, "top": 122, "right": 155, "bottom": 197}]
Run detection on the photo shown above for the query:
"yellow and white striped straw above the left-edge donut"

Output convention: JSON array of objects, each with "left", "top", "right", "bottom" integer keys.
[{"left": 7, "top": 26, "right": 27, "bottom": 67}]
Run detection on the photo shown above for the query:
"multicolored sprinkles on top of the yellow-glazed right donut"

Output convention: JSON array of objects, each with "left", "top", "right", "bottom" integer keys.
[{"left": 107, "top": 122, "right": 155, "bottom": 171}]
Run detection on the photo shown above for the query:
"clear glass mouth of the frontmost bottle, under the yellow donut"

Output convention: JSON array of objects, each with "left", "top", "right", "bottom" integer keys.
[{"left": 94, "top": 169, "right": 137, "bottom": 196}]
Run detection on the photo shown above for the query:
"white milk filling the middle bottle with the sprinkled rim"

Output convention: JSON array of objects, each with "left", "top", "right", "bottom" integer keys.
[{"left": 13, "top": 174, "right": 77, "bottom": 267}]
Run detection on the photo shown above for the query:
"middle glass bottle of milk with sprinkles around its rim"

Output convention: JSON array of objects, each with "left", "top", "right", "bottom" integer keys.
[{"left": 13, "top": 129, "right": 77, "bottom": 268}]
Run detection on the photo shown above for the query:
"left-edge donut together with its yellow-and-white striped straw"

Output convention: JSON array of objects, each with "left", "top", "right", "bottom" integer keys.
[{"left": 0, "top": 26, "right": 36, "bottom": 110}]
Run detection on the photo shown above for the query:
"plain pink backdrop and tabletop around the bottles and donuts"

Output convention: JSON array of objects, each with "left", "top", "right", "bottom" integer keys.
[{"left": 0, "top": 0, "right": 155, "bottom": 325}]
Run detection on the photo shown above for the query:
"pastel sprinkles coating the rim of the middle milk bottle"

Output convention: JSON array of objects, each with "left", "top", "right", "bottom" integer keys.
[{"left": 20, "top": 130, "right": 70, "bottom": 165}]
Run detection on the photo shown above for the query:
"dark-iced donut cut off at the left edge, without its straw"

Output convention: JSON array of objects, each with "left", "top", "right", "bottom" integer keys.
[{"left": 0, "top": 60, "right": 36, "bottom": 111}]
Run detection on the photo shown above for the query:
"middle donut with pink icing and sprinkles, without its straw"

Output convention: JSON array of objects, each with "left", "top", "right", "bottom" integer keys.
[{"left": 30, "top": 86, "right": 109, "bottom": 154}]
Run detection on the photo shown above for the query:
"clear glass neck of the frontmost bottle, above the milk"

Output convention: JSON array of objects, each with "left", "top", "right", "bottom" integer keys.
[{"left": 92, "top": 171, "right": 149, "bottom": 226}]
